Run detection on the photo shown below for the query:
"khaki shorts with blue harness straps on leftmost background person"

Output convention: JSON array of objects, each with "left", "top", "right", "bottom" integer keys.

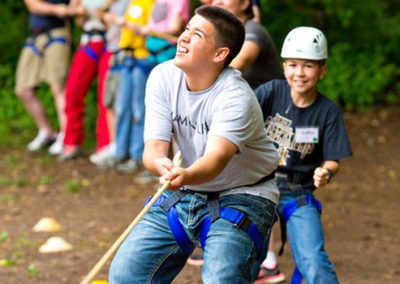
[{"left": 15, "top": 28, "right": 71, "bottom": 92}]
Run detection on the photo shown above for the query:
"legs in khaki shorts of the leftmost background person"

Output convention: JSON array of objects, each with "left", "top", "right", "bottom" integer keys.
[{"left": 15, "top": 28, "right": 70, "bottom": 151}]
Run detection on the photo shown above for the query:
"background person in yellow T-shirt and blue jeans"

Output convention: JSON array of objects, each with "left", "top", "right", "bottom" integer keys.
[{"left": 110, "top": 0, "right": 154, "bottom": 173}]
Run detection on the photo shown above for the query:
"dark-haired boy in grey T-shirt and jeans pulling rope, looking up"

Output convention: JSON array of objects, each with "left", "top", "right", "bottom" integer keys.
[{"left": 109, "top": 5, "right": 279, "bottom": 284}]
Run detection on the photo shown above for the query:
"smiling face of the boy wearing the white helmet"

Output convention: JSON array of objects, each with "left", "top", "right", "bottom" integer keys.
[{"left": 283, "top": 59, "right": 326, "bottom": 95}]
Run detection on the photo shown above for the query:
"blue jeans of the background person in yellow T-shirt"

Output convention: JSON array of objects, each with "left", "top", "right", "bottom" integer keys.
[{"left": 115, "top": 56, "right": 151, "bottom": 160}]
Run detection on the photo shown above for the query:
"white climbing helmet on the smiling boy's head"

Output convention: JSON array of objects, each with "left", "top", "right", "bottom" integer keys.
[{"left": 281, "top": 27, "right": 328, "bottom": 60}]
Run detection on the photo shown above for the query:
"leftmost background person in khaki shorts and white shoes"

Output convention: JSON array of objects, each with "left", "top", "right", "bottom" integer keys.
[{"left": 15, "top": 0, "right": 71, "bottom": 155}]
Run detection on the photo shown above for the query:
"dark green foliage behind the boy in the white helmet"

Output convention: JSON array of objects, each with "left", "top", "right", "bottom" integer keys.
[{"left": 261, "top": 0, "right": 400, "bottom": 109}]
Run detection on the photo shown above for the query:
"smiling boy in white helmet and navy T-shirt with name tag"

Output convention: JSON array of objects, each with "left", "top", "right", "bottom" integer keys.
[{"left": 255, "top": 27, "right": 352, "bottom": 284}]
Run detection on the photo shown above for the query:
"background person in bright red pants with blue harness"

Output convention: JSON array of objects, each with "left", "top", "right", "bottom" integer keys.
[{"left": 59, "top": 0, "right": 113, "bottom": 160}]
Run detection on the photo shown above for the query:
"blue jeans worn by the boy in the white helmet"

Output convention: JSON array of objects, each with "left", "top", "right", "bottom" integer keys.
[{"left": 278, "top": 194, "right": 339, "bottom": 284}]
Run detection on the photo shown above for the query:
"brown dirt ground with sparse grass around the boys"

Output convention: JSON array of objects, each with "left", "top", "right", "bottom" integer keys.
[{"left": 0, "top": 107, "right": 400, "bottom": 284}]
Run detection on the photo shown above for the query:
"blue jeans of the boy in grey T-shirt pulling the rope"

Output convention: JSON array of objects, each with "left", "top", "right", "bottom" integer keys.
[{"left": 109, "top": 191, "right": 276, "bottom": 284}]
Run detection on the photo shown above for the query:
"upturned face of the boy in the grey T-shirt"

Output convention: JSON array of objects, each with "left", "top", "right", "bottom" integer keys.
[{"left": 174, "top": 15, "right": 225, "bottom": 72}]
